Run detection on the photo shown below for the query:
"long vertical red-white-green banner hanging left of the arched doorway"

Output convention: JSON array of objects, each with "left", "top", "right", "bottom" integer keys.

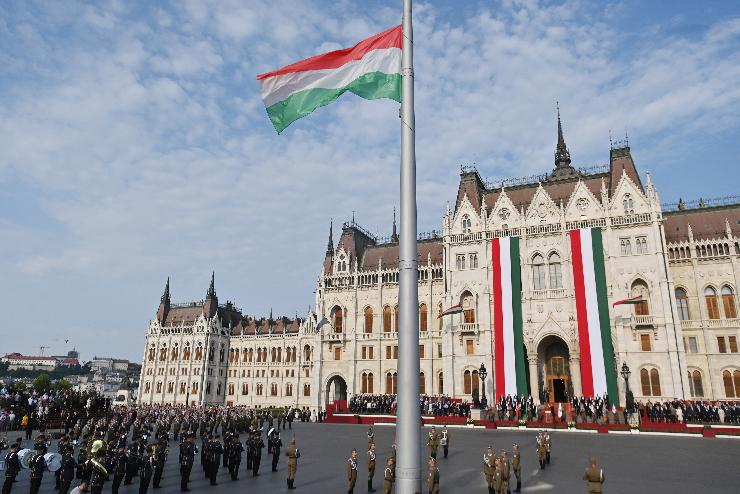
[{"left": 491, "top": 237, "right": 527, "bottom": 400}]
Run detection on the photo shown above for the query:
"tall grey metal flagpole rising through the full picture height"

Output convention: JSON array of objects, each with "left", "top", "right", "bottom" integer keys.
[{"left": 396, "top": 0, "right": 421, "bottom": 494}]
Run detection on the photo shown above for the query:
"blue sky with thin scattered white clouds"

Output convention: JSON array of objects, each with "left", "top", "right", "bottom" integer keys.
[{"left": 0, "top": 0, "right": 740, "bottom": 359}]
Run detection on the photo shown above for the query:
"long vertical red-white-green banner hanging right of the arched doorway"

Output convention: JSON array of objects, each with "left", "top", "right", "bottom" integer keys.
[{"left": 570, "top": 228, "right": 618, "bottom": 404}]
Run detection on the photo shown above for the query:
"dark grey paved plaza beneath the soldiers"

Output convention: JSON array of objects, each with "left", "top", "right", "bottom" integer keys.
[{"left": 11, "top": 423, "right": 740, "bottom": 494}]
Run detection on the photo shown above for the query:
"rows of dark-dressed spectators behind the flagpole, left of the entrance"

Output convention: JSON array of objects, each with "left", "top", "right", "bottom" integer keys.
[{"left": 347, "top": 394, "right": 472, "bottom": 417}]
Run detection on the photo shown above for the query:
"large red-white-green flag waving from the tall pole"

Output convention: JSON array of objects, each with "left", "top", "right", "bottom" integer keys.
[{"left": 257, "top": 25, "right": 402, "bottom": 134}]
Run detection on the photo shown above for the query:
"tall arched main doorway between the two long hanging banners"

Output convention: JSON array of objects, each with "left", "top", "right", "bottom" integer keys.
[{"left": 537, "top": 336, "right": 573, "bottom": 403}]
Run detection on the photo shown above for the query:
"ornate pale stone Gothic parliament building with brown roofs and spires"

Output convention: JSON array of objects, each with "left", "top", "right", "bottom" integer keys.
[{"left": 139, "top": 117, "right": 740, "bottom": 410}]
